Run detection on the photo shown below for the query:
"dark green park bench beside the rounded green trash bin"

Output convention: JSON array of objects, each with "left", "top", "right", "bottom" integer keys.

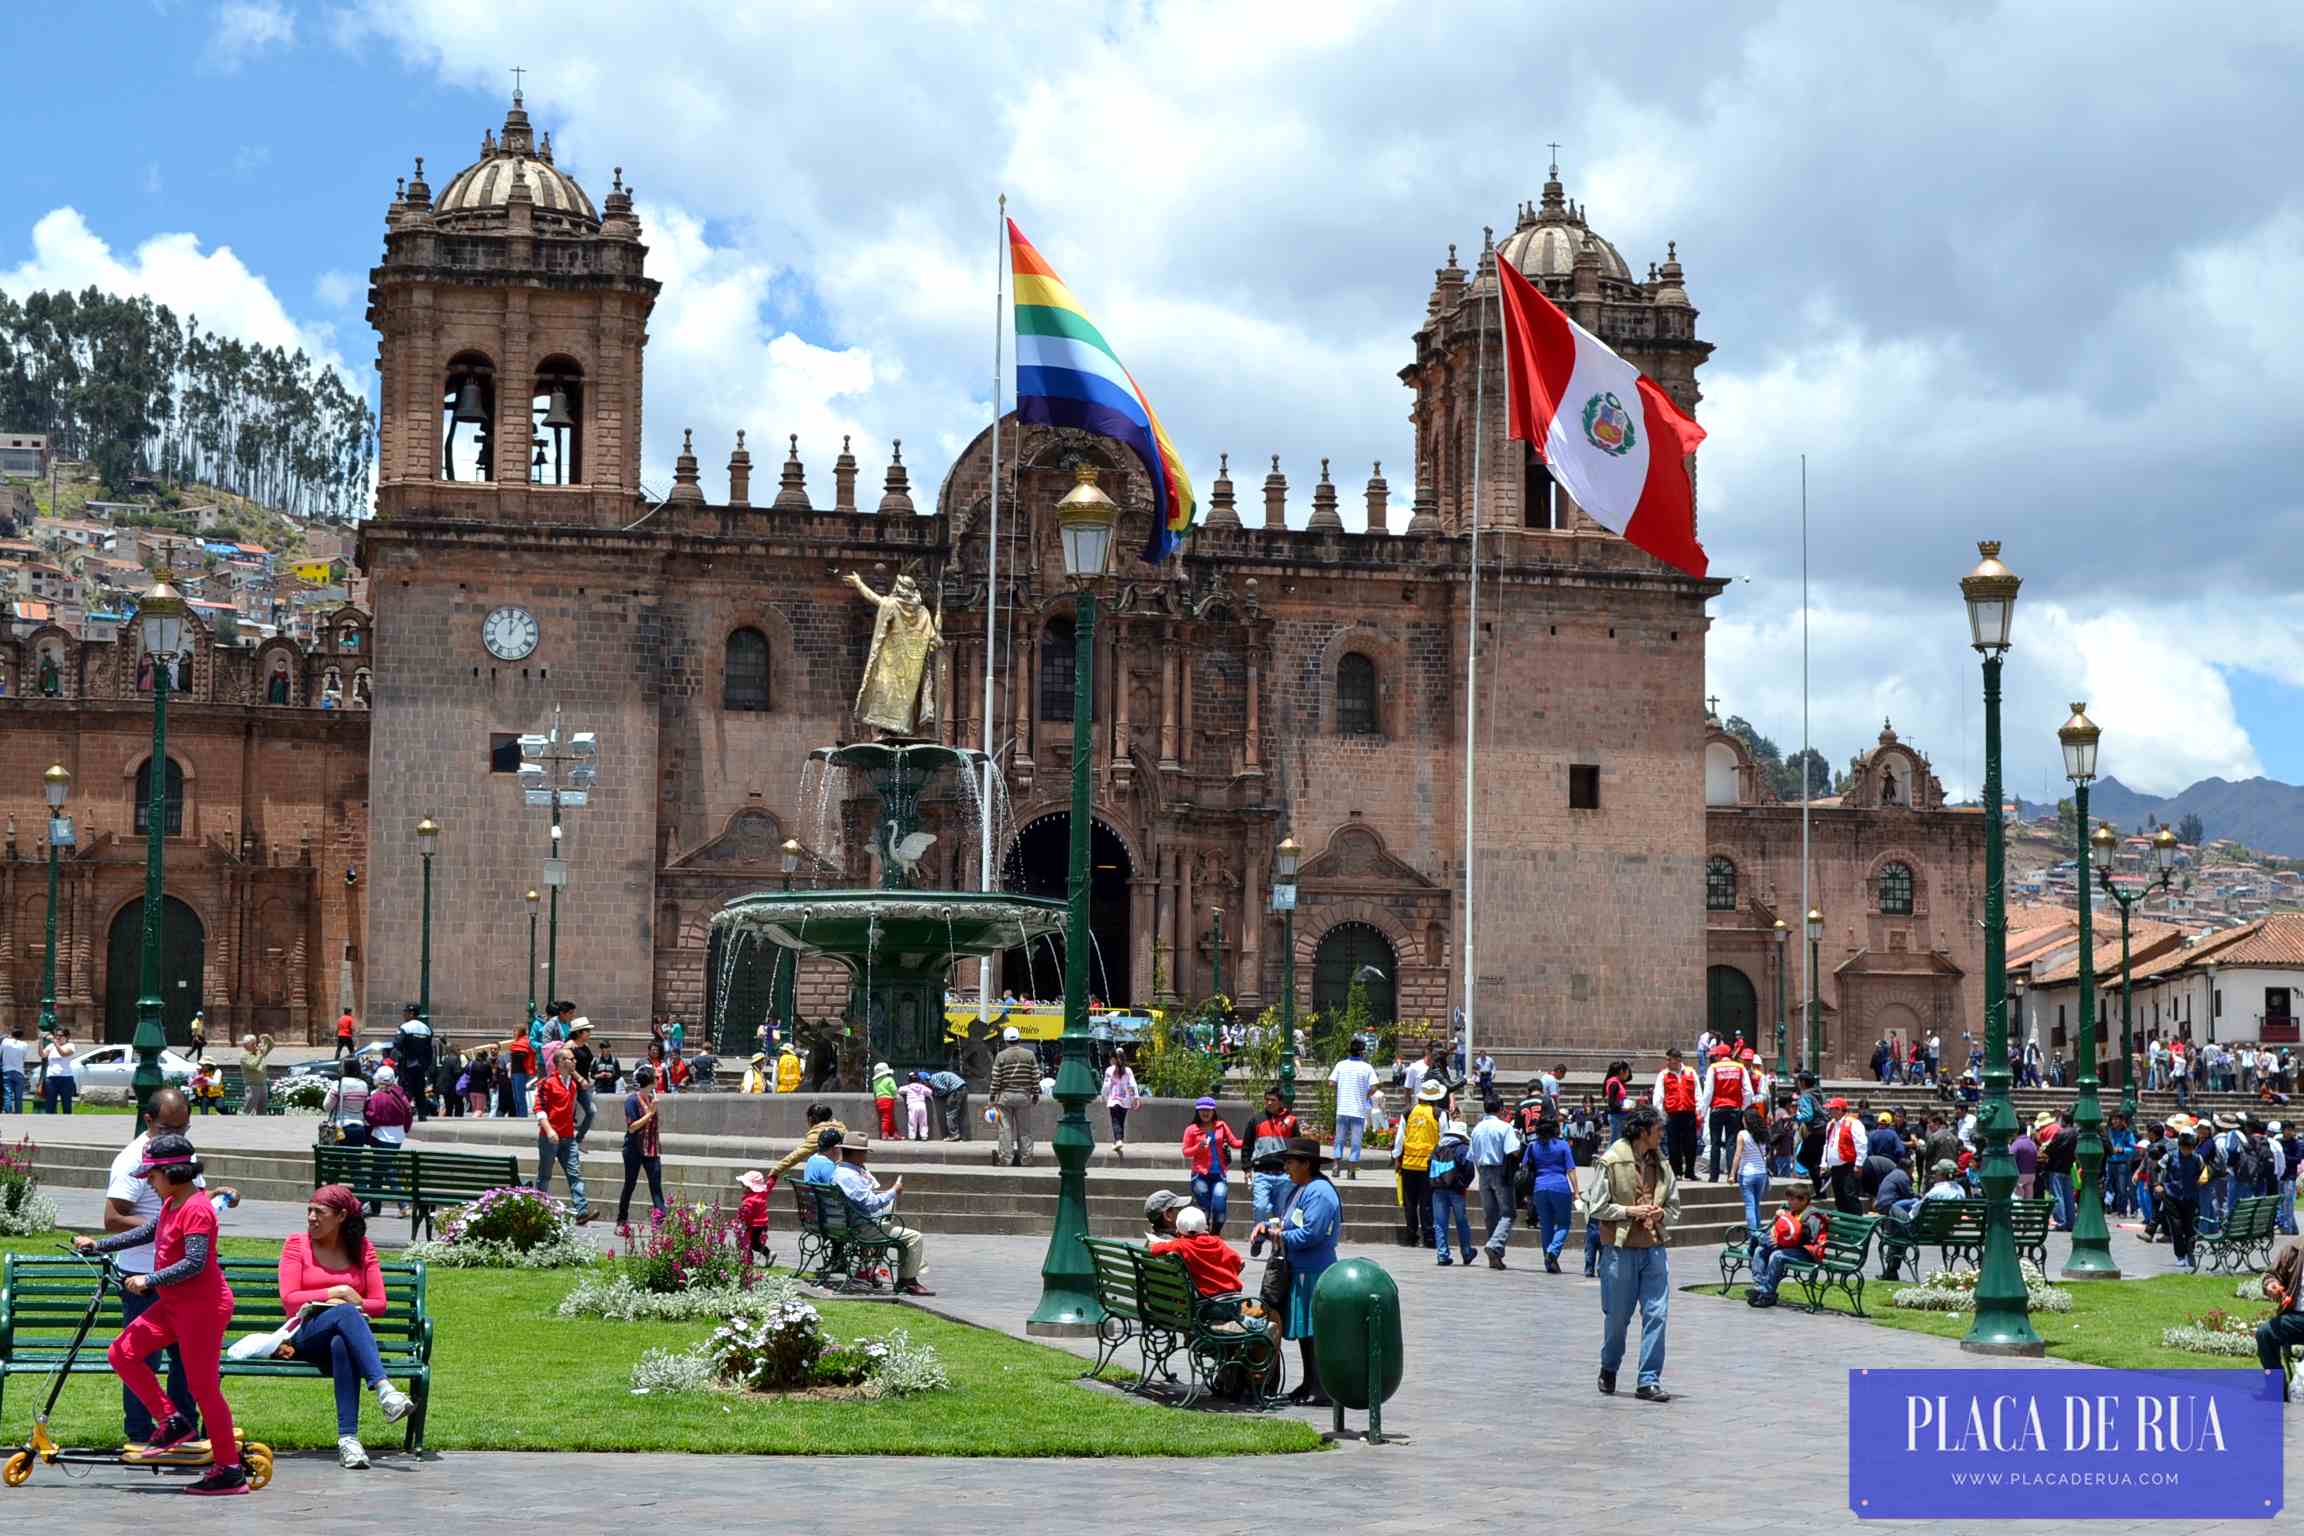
[{"left": 1081, "top": 1237, "right": 1281, "bottom": 1407}]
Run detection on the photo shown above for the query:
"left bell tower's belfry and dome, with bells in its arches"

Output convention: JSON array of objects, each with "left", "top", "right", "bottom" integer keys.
[{"left": 369, "top": 92, "right": 657, "bottom": 527}]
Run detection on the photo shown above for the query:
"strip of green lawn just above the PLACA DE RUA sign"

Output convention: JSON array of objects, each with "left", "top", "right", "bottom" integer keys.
[{"left": 1689, "top": 1276, "right": 2267, "bottom": 1370}]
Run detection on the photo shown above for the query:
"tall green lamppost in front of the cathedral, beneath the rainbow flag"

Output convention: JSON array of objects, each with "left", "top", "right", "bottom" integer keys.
[{"left": 1025, "top": 465, "right": 1120, "bottom": 1336}]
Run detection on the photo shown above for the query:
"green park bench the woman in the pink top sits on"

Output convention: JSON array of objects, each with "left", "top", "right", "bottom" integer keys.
[{"left": 0, "top": 1253, "right": 433, "bottom": 1455}]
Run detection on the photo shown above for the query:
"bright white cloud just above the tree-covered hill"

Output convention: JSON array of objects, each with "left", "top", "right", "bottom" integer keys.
[{"left": 0, "top": 207, "right": 343, "bottom": 385}]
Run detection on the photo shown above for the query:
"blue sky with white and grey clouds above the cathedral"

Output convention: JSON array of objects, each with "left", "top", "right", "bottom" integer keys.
[{"left": 0, "top": 0, "right": 2304, "bottom": 799}]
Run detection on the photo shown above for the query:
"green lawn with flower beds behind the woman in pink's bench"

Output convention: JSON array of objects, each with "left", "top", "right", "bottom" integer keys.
[{"left": 0, "top": 1237, "right": 1320, "bottom": 1455}]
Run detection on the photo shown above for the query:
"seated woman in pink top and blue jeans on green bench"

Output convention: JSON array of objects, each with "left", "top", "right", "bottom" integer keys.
[{"left": 279, "top": 1184, "right": 410, "bottom": 1467}]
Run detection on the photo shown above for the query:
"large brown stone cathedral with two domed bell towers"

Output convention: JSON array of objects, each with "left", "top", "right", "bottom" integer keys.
[{"left": 362, "top": 99, "right": 1723, "bottom": 1050}]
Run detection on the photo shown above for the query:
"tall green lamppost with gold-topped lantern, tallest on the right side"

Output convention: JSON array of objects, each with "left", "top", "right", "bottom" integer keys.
[{"left": 1961, "top": 539, "right": 2046, "bottom": 1354}]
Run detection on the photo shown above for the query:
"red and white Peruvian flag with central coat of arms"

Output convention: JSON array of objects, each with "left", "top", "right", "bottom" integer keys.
[{"left": 1495, "top": 260, "right": 1707, "bottom": 576}]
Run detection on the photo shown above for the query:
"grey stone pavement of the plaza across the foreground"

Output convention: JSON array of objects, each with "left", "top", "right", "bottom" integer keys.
[{"left": 0, "top": 1119, "right": 2304, "bottom": 1536}]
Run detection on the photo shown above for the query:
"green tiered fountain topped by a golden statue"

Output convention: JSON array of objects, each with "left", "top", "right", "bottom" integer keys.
[{"left": 712, "top": 578, "right": 1064, "bottom": 1087}]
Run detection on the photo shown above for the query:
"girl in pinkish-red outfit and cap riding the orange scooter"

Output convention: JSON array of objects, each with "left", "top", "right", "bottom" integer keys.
[{"left": 71, "top": 1135, "right": 249, "bottom": 1495}]
